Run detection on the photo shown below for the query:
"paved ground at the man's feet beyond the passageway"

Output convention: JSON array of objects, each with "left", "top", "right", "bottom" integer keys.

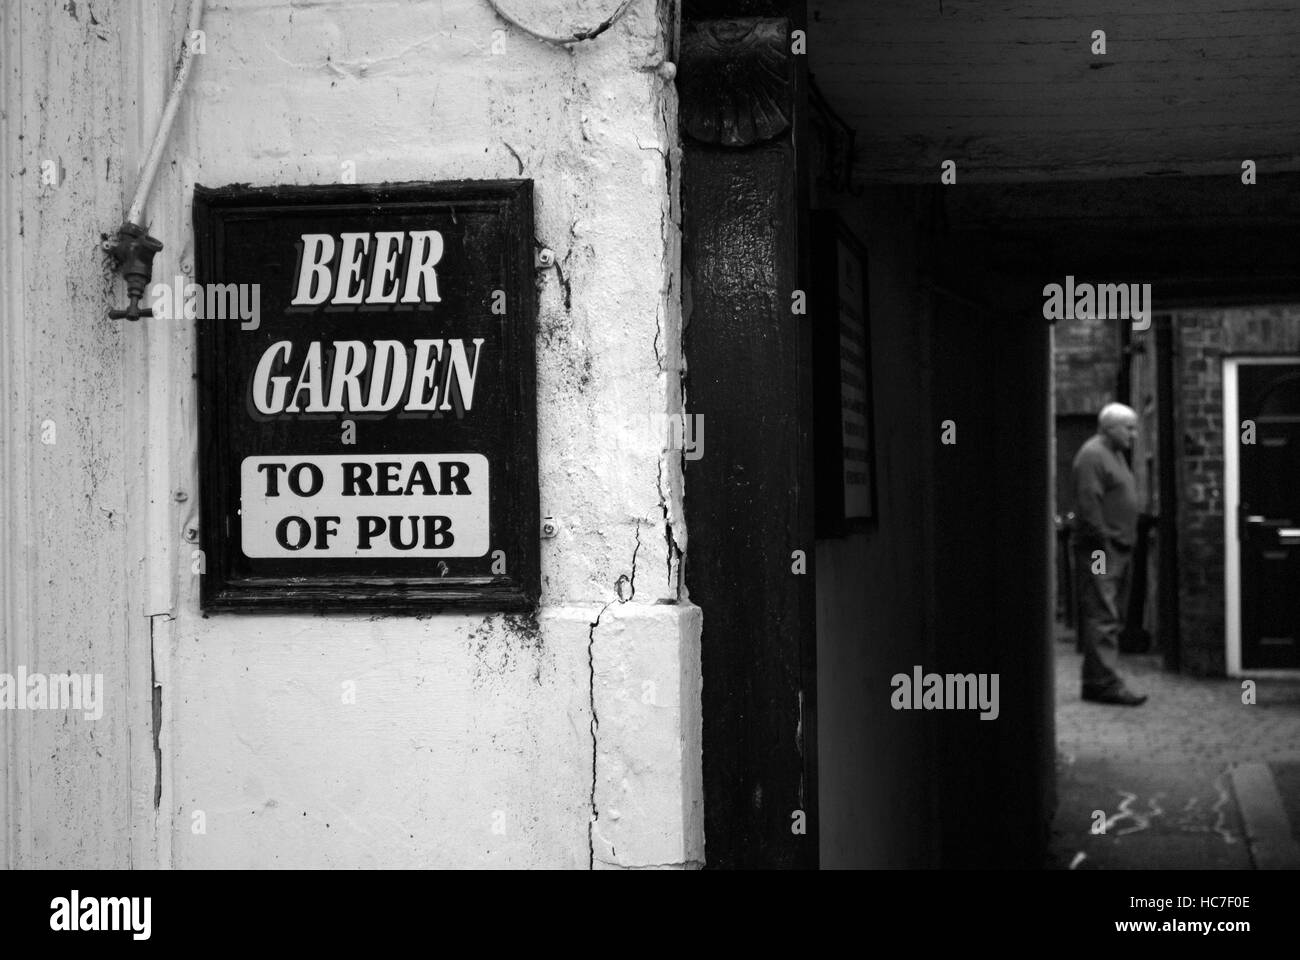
[{"left": 1050, "top": 637, "right": 1300, "bottom": 870}]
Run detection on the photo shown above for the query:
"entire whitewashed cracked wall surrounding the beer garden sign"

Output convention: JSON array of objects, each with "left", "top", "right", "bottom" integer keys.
[{"left": 0, "top": 0, "right": 703, "bottom": 868}]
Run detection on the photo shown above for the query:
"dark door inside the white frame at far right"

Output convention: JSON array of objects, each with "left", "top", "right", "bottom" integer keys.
[{"left": 1238, "top": 362, "right": 1300, "bottom": 670}]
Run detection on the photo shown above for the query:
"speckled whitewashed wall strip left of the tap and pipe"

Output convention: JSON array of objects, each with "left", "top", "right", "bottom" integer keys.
[{"left": 0, "top": 1, "right": 143, "bottom": 866}]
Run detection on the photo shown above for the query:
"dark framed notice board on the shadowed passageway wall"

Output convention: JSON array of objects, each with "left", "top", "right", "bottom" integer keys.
[{"left": 809, "top": 211, "right": 876, "bottom": 536}]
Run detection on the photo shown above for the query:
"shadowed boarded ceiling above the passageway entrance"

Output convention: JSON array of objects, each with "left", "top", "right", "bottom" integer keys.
[{"left": 809, "top": 0, "right": 1300, "bottom": 182}]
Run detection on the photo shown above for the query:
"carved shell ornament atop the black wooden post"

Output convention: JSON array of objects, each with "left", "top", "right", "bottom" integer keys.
[{"left": 677, "top": 18, "right": 793, "bottom": 147}]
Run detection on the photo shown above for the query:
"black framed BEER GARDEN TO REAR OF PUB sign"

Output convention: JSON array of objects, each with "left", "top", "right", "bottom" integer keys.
[{"left": 187, "top": 181, "right": 540, "bottom": 613}]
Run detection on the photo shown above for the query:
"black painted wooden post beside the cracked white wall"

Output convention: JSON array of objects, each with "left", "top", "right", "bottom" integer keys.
[{"left": 679, "top": 0, "right": 818, "bottom": 868}]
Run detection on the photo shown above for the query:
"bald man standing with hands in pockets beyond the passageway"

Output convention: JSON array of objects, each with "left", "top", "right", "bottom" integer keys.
[{"left": 1074, "top": 403, "right": 1147, "bottom": 706}]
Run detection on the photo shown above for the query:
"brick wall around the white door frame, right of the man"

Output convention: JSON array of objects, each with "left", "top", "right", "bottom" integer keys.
[{"left": 1174, "top": 304, "right": 1300, "bottom": 675}]
